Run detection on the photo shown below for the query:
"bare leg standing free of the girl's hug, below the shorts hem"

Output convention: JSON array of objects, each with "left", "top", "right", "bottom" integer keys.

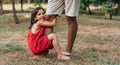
[{"left": 66, "top": 16, "right": 77, "bottom": 53}]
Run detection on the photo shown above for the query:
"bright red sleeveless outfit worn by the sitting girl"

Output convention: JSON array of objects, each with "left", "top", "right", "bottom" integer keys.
[{"left": 28, "top": 27, "right": 53, "bottom": 55}]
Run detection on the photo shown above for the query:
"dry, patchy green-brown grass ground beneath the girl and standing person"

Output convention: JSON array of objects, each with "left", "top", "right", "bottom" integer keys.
[{"left": 0, "top": 13, "right": 120, "bottom": 65}]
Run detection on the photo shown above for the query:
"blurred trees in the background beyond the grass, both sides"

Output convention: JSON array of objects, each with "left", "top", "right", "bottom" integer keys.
[{"left": 0, "top": 0, "right": 120, "bottom": 24}]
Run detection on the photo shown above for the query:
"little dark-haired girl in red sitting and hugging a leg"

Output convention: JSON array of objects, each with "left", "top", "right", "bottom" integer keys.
[{"left": 28, "top": 7, "right": 70, "bottom": 60}]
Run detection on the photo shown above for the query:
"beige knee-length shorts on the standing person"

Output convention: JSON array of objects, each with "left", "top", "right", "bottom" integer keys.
[{"left": 46, "top": 0, "right": 80, "bottom": 17}]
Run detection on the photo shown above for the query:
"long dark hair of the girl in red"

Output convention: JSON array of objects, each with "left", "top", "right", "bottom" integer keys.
[{"left": 29, "top": 7, "right": 45, "bottom": 29}]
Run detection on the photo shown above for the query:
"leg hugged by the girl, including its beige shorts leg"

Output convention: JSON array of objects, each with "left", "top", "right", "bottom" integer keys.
[{"left": 45, "top": 0, "right": 65, "bottom": 53}]
